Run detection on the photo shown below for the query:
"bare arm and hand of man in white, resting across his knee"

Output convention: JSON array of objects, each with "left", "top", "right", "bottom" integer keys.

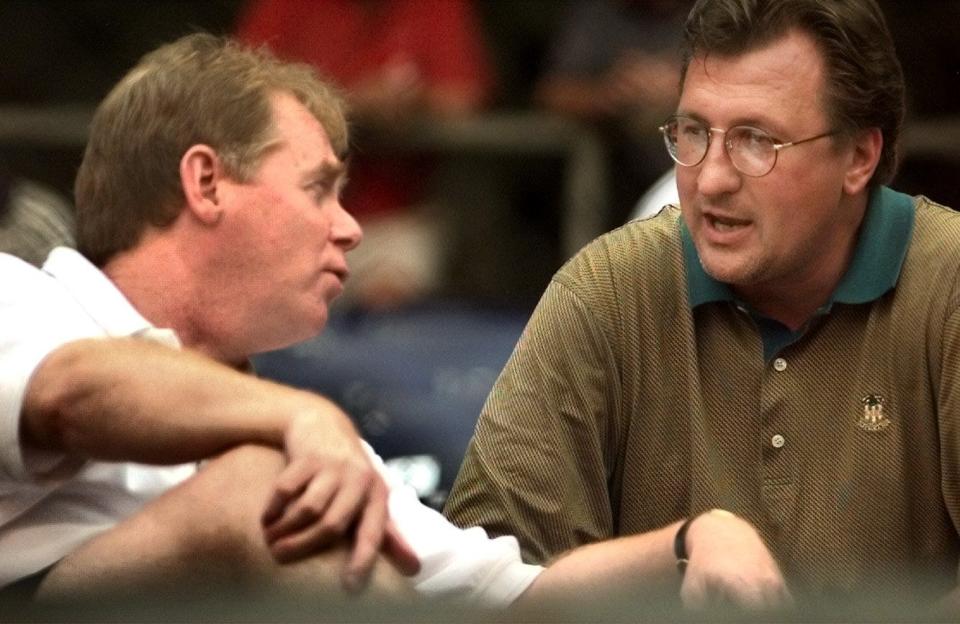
[{"left": 21, "top": 339, "right": 418, "bottom": 587}]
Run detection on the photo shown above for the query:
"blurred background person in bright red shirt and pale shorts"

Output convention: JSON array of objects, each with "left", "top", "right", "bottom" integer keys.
[{"left": 236, "top": 0, "right": 493, "bottom": 309}]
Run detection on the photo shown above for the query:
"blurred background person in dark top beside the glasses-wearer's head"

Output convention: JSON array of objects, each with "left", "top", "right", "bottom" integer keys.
[{"left": 535, "top": 0, "right": 690, "bottom": 228}]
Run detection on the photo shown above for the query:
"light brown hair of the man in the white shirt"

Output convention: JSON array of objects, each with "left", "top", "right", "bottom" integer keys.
[{"left": 74, "top": 33, "right": 347, "bottom": 266}]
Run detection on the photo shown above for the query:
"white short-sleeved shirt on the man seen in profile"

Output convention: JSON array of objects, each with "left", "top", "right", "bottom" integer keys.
[{"left": 0, "top": 247, "right": 542, "bottom": 607}]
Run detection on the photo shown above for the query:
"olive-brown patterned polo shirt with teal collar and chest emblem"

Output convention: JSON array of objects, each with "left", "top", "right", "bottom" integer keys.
[{"left": 445, "top": 190, "right": 960, "bottom": 598}]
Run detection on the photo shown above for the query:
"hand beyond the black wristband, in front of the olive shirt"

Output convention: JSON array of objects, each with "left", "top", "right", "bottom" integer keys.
[{"left": 680, "top": 509, "right": 793, "bottom": 610}]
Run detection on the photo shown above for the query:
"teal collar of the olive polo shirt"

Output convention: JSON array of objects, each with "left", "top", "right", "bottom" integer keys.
[{"left": 680, "top": 186, "right": 914, "bottom": 308}]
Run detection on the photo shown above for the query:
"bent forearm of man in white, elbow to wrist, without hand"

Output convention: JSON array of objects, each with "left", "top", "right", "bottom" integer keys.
[{"left": 21, "top": 339, "right": 336, "bottom": 464}]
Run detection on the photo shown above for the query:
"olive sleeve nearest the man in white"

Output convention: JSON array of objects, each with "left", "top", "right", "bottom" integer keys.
[{"left": 444, "top": 270, "right": 619, "bottom": 563}]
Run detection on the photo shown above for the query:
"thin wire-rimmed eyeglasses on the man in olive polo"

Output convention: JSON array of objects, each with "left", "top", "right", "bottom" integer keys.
[{"left": 660, "top": 115, "right": 836, "bottom": 178}]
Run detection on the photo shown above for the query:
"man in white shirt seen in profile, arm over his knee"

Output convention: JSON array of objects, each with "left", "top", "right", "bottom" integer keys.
[{"left": 0, "top": 34, "right": 704, "bottom": 617}]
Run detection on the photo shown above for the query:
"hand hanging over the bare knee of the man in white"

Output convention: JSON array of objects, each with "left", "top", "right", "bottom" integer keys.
[{"left": 263, "top": 404, "right": 419, "bottom": 590}]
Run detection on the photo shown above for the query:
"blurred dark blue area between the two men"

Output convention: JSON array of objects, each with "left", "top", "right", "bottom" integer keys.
[{"left": 254, "top": 303, "right": 529, "bottom": 504}]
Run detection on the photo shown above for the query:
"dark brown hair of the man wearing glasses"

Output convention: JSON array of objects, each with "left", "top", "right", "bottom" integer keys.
[{"left": 681, "top": 0, "right": 905, "bottom": 185}]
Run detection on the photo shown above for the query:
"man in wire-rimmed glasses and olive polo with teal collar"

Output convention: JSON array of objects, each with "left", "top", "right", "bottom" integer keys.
[{"left": 446, "top": 0, "right": 960, "bottom": 607}]
